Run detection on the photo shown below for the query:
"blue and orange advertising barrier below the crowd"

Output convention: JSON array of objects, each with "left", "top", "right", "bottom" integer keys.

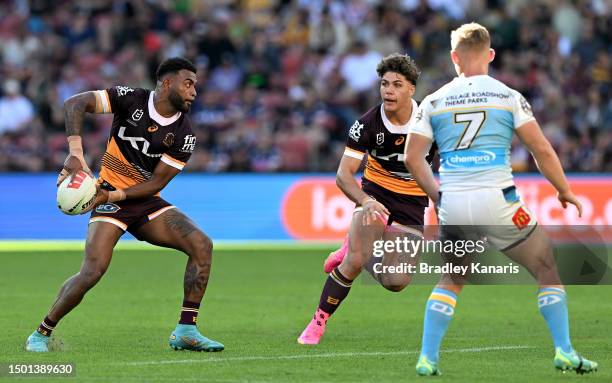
[{"left": 0, "top": 173, "right": 612, "bottom": 240}]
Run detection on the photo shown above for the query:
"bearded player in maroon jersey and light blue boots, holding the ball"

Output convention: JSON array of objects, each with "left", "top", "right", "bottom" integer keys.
[{"left": 26, "top": 58, "right": 224, "bottom": 352}]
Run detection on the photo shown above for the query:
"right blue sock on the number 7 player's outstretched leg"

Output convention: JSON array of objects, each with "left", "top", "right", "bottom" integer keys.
[{"left": 538, "top": 287, "right": 572, "bottom": 352}]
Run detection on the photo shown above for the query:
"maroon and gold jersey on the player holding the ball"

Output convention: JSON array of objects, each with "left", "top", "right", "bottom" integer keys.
[{"left": 94, "top": 86, "right": 196, "bottom": 188}]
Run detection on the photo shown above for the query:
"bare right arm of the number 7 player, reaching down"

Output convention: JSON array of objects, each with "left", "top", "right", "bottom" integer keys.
[{"left": 516, "top": 120, "right": 582, "bottom": 216}]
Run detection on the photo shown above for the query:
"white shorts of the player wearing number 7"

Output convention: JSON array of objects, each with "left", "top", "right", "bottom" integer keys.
[{"left": 438, "top": 186, "right": 537, "bottom": 251}]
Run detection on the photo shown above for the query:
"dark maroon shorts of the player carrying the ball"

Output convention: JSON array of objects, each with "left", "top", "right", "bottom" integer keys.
[{"left": 89, "top": 197, "right": 175, "bottom": 234}]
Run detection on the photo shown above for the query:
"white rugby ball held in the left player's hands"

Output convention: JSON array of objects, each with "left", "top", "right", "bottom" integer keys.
[{"left": 57, "top": 170, "right": 96, "bottom": 215}]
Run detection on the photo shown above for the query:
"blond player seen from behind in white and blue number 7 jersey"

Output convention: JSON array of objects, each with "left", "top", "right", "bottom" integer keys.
[{"left": 405, "top": 23, "right": 597, "bottom": 375}]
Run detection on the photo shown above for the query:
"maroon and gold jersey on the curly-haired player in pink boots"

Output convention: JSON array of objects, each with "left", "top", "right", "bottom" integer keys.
[{"left": 344, "top": 100, "right": 426, "bottom": 196}]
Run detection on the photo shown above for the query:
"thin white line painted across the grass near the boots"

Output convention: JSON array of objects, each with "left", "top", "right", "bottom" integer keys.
[{"left": 119, "top": 345, "right": 535, "bottom": 366}]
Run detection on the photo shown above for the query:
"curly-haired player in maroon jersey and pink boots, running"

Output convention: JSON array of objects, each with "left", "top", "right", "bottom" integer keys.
[{"left": 298, "top": 53, "right": 428, "bottom": 344}]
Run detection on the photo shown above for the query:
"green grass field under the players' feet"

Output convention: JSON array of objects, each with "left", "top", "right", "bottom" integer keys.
[{"left": 0, "top": 245, "right": 612, "bottom": 382}]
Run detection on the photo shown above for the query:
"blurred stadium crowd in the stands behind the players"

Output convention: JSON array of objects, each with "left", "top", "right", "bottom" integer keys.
[{"left": 0, "top": 0, "right": 612, "bottom": 172}]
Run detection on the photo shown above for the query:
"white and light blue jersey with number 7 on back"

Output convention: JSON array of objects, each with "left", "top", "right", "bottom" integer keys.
[{"left": 410, "top": 75, "right": 534, "bottom": 192}]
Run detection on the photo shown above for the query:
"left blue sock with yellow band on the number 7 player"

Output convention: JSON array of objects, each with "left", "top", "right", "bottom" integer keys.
[{"left": 421, "top": 287, "right": 457, "bottom": 363}]
